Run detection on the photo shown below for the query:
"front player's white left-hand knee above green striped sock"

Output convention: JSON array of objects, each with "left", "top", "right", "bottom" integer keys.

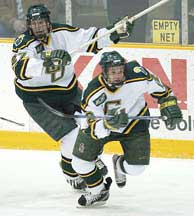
[{"left": 71, "top": 155, "right": 95, "bottom": 174}]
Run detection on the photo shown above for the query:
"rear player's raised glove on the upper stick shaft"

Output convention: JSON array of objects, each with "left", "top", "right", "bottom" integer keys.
[{"left": 107, "top": 16, "right": 134, "bottom": 44}]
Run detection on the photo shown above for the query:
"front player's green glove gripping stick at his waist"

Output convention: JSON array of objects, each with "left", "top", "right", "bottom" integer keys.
[{"left": 104, "top": 108, "right": 128, "bottom": 130}]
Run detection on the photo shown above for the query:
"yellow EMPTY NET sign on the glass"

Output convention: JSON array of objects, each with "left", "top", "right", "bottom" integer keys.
[{"left": 152, "top": 20, "right": 179, "bottom": 44}]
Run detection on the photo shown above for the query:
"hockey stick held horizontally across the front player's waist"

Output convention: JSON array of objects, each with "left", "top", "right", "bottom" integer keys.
[{"left": 38, "top": 98, "right": 166, "bottom": 121}]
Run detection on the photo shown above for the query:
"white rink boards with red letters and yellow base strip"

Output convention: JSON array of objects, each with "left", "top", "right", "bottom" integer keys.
[{"left": 0, "top": 40, "right": 194, "bottom": 158}]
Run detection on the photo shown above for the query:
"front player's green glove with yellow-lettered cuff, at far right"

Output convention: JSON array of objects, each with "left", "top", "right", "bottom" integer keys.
[{"left": 158, "top": 96, "right": 183, "bottom": 127}]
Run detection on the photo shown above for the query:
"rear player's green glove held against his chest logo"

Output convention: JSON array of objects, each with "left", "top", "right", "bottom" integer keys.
[{"left": 41, "top": 50, "right": 71, "bottom": 73}]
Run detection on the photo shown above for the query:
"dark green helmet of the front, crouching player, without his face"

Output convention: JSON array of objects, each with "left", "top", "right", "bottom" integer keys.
[{"left": 99, "top": 51, "right": 125, "bottom": 88}]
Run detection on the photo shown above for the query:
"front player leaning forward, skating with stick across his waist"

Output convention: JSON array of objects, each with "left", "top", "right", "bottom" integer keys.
[{"left": 72, "top": 51, "right": 182, "bottom": 206}]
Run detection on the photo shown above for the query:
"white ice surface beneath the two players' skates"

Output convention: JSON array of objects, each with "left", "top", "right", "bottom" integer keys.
[{"left": 0, "top": 150, "right": 194, "bottom": 216}]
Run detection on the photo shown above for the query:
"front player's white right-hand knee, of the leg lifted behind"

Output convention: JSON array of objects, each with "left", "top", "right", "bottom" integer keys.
[{"left": 123, "top": 161, "right": 146, "bottom": 176}]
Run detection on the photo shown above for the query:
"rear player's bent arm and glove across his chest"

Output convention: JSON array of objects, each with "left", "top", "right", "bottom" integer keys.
[{"left": 12, "top": 48, "right": 71, "bottom": 80}]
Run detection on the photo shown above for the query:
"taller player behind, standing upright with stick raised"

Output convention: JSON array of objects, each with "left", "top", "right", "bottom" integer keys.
[{"left": 12, "top": 4, "right": 132, "bottom": 189}]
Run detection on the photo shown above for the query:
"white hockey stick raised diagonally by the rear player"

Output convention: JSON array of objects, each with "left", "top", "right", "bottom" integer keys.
[{"left": 69, "top": 0, "right": 169, "bottom": 54}]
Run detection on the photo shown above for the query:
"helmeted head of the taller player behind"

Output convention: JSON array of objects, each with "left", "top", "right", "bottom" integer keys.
[{"left": 26, "top": 4, "right": 51, "bottom": 40}]
